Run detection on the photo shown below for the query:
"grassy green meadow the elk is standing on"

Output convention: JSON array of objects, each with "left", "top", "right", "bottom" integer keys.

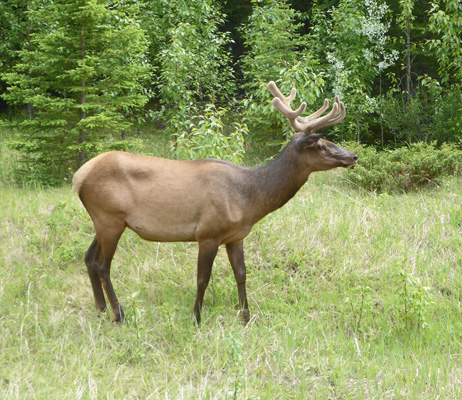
[{"left": 0, "top": 136, "right": 462, "bottom": 399}]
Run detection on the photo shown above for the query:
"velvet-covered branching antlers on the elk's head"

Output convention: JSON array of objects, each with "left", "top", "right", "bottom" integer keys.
[{"left": 268, "top": 81, "right": 345, "bottom": 135}]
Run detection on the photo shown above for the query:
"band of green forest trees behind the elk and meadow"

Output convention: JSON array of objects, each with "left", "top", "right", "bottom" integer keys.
[{"left": 0, "top": 0, "right": 462, "bottom": 184}]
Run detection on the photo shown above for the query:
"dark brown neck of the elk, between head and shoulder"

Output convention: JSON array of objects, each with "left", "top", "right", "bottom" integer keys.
[{"left": 245, "top": 140, "right": 312, "bottom": 219}]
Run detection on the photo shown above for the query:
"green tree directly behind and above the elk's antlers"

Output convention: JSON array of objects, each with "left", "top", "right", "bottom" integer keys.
[{"left": 241, "top": 0, "right": 324, "bottom": 133}]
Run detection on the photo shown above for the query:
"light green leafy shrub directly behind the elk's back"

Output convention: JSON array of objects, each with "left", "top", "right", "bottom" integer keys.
[{"left": 172, "top": 104, "right": 248, "bottom": 164}]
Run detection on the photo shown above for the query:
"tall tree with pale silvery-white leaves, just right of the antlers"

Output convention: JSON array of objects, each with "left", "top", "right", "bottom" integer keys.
[{"left": 324, "top": 0, "right": 397, "bottom": 142}]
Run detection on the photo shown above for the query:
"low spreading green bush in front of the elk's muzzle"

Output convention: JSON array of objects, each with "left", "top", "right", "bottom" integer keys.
[{"left": 344, "top": 142, "right": 462, "bottom": 193}]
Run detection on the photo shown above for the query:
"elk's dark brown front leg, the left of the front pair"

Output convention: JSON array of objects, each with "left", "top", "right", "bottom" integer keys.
[{"left": 193, "top": 240, "right": 218, "bottom": 325}]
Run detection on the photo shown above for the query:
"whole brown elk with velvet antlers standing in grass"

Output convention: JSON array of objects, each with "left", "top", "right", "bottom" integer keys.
[{"left": 73, "top": 82, "right": 358, "bottom": 324}]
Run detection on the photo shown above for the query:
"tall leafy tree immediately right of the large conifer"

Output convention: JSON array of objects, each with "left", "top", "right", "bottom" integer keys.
[{"left": 150, "top": 0, "right": 234, "bottom": 133}]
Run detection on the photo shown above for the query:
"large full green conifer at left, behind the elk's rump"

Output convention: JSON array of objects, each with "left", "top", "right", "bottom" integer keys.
[{"left": 3, "top": 0, "right": 150, "bottom": 183}]
